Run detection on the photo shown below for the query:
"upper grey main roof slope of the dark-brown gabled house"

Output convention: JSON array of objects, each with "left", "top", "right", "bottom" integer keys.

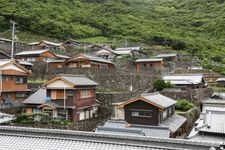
[{"left": 141, "top": 92, "right": 176, "bottom": 108}]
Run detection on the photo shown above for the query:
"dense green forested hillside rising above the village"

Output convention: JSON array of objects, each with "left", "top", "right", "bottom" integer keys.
[{"left": 0, "top": 0, "right": 225, "bottom": 73}]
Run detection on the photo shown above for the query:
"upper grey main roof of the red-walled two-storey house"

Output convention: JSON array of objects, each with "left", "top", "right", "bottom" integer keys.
[{"left": 60, "top": 74, "right": 98, "bottom": 86}]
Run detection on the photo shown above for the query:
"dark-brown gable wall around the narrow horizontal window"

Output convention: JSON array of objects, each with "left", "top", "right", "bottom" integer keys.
[{"left": 124, "top": 100, "right": 160, "bottom": 125}]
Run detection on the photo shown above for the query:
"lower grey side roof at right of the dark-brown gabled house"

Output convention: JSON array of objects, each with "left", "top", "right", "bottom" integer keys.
[{"left": 160, "top": 114, "right": 187, "bottom": 133}]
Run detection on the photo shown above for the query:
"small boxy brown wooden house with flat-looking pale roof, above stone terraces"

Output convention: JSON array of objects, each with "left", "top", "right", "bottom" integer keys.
[{"left": 134, "top": 58, "right": 164, "bottom": 71}]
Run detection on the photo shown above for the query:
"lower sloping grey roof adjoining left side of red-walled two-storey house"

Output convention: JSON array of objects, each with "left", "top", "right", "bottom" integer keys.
[{"left": 23, "top": 88, "right": 46, "bottom": 104}]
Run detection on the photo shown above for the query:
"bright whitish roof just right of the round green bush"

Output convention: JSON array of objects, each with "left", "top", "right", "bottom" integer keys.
[{"left": 163, "top": 74, "right": 203, "bottom": 85}]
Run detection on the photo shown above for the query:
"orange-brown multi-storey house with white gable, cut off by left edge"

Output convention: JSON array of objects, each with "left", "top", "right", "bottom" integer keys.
[{"left": 0, "top": 59, "right": 30, "bottom": 102}]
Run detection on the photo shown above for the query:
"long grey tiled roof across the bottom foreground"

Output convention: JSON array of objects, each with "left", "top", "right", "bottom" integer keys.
[{"left": 0, "top": 126, "right": 222, "bottom": 150}]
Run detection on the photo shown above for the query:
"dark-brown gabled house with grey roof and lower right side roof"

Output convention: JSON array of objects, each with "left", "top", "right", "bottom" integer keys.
[{"left": 114, "top": 93, "right": 186, "bottom": 137}]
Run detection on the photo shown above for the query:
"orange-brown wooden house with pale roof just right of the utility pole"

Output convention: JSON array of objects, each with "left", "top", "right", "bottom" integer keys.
[{"left": 15, "top": 49, "right": 57, "bottom": 62}]
